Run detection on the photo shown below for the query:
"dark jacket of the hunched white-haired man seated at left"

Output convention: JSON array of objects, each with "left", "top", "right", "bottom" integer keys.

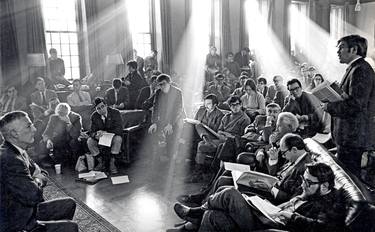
[{"left": 43, "top": 112, "right": 82, "bottom": 139}]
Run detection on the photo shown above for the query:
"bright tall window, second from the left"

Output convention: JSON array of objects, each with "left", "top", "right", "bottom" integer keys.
[{"left": 127, "top": 0, "right": 152, "bottom": 57}]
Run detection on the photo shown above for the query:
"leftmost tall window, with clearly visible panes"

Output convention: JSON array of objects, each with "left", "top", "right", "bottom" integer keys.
[{"left": 42, "top": 0, "right": 80, "bottom": 80}]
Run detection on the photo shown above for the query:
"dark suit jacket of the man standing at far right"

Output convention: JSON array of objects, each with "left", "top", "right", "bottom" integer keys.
[{"left": 327, "top": 58, "right": 375, "bottom": 148}]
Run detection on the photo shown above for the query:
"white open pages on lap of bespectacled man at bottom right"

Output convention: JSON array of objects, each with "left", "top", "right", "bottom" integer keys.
[{"left": 242, "top": 194, "right": 285, "bottom": 225}]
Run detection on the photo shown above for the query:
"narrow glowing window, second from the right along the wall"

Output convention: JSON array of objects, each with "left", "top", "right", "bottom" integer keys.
[{"left": 289, "top": 1, "right": 308, "bottom": 54}]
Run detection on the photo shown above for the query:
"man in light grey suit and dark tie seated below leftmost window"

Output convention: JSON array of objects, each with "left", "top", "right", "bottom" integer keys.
[{"left": 30, "top": 77, "right": 57, "bottom": 120}]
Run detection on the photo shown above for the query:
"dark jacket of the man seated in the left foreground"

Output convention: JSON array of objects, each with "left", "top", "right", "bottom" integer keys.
[{"left": 0, "top": 141, "right": 43, "bottom": 232}]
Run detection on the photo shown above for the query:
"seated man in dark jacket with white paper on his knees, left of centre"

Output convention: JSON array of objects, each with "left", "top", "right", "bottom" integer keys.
[{"left": 87, "top": 98, "right": 122, "bottom": 174}]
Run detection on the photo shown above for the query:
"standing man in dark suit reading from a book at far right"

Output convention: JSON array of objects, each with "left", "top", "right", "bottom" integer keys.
[{"left": 322, "top": 35, "right": 375, "bottom": 177}]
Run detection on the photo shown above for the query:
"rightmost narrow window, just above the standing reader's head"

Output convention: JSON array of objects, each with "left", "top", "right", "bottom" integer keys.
[{"left": 330, "top": 5, "right": 344, "bottom": 40}]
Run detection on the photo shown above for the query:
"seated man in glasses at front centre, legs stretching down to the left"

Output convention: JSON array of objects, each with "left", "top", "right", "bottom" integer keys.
[{"left": 195, "top": 96, "right": 250, "bottom": 179}]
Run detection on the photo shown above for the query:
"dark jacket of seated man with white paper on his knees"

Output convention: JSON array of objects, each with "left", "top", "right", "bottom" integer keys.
[{"left": 91, "top": 107, "right": 122, "bottom": 137}]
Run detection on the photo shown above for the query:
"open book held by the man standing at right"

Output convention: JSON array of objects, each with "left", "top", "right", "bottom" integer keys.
[{"left": 311, "top": 81, "right": 343, "bottom": 102}]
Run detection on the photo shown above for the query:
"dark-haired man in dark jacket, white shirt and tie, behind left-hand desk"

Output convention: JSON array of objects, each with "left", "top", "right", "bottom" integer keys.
[{"left": 104, "top": 78, "right": 129, "bottom": 110}]
